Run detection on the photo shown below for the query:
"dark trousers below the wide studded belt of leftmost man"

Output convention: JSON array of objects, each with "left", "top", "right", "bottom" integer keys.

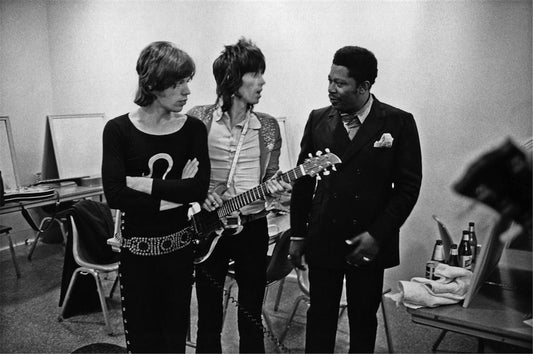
[{"left": 119, "top": 246, "right": 194, "bottom": 353}]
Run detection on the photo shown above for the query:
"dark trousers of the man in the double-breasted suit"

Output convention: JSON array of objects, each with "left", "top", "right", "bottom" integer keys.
[{"left": 305, "top": 266, "right": 383, "bottom": 353}]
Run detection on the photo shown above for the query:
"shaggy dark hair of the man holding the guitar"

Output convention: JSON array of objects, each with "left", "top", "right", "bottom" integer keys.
[{"left": 213, "top": 38, "right": 266, "bottom": 112}]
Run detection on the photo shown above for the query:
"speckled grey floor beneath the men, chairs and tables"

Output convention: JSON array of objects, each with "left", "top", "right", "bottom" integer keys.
[{"left": 0, "top": 242, "right": 516, "bottom": 353}]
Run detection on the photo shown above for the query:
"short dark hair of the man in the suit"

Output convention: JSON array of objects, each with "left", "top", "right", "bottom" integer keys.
[{"left": 333, "top": 46, "right": 378, "bottom": 86}]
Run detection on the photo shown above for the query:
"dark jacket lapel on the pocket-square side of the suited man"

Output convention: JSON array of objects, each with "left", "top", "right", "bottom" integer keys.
[{"left": 341, "top": 97, "right": 385, "bottom": 162}]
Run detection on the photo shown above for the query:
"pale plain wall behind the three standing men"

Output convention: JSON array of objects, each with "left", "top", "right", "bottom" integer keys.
[{"left": 0, "top": 0, "right": 532, "bottom": 281}]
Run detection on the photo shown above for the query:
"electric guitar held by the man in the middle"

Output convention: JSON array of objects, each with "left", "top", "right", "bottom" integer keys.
[{"left": 189, "top": 149, "right": 341, "bottom": 264}]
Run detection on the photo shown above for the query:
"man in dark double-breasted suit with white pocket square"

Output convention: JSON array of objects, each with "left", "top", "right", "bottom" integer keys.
[{"left": 289, "top": 46, "right": 422, "bottom": 352}]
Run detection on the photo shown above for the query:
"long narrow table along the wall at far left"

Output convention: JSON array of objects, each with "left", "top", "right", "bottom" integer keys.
[{"left": 0, "top": 184, "right": 104, "bottom": 260}]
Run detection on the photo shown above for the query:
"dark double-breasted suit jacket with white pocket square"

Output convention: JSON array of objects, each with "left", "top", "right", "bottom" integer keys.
[{"left": 291, "top": 97, "right": 422, "bottom": 268}]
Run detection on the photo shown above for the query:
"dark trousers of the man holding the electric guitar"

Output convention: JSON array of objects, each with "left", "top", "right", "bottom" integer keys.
[{"left": 196, "top": 218, "right": 268, "bottom": 353}]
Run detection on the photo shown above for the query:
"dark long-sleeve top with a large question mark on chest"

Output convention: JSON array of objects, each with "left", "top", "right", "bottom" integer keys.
[{"left": 102, "top": 114, "right": 210, "bottom": 237}]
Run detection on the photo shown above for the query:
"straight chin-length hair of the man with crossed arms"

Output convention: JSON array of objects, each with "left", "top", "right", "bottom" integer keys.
[{"left": 134, "top": 41, "right": 196, "bottom": 107}]
